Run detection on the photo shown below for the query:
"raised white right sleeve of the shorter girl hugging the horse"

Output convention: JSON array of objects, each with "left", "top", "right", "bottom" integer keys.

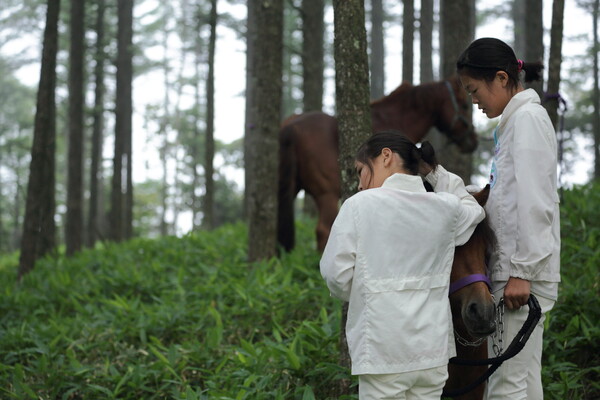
[{"left": 425, "top": 165, "right": 485, "bottom": 246}]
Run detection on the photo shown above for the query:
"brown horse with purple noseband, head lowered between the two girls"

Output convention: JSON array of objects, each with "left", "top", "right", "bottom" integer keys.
[{"left": 444, "top": 185, "right": 496, "bottom": 400}]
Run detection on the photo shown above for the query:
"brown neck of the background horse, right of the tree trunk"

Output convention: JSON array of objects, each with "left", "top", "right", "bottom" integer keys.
[{"left": 371, "top": 83, "right": 441, "bottom": 143}]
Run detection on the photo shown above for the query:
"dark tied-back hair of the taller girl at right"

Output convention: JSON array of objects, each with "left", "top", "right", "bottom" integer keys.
[{"left": 456, "top": 38, "right": 544, "bottom": 87}]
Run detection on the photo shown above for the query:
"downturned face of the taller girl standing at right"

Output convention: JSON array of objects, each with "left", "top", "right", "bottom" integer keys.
[{"left": 460, "top": 71, "right": 512, "bottom": 118}]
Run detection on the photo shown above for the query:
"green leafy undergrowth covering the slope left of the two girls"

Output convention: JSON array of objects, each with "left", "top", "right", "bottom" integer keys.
[{"left": 0, "top": 221, "right": 356, "bottom": 399}]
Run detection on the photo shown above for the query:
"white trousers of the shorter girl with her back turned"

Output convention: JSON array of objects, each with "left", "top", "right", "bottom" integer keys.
[{"left": 358, "top": 365, "right": 448, "bottom": 400}]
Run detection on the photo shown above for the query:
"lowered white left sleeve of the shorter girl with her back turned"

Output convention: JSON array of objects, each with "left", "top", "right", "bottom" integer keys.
[{"left": 320, "top": 199, "right": 357, "bottom": 301}]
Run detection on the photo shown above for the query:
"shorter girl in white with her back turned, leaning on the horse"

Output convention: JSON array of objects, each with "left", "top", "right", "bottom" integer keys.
[{"left": 320, "top": 131, "right": 484, "bottom": 400}]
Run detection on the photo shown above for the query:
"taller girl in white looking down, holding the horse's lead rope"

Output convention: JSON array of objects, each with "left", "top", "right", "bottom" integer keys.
[{"left": 456, "top": 38, "right": 560, "bottom": 400}]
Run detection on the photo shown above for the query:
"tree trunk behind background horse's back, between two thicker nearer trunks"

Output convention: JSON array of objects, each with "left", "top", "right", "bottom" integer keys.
[{"left": 302, "top": 0, "right": 325, "bottom": 112}]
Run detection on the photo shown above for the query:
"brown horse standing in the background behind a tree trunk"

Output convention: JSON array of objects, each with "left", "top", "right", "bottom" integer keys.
[{"left": 277, "top": 79, "right": 477, "bottom": 251}]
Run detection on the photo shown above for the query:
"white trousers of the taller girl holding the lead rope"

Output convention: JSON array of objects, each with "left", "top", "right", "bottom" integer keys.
[{"left": 484, "top": 288, "right": 555, "bottom": 400}]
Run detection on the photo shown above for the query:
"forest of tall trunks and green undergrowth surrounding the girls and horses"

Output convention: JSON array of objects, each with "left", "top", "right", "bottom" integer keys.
[{"left": 0, "top": 0, "right": 600, "bottom": 399}]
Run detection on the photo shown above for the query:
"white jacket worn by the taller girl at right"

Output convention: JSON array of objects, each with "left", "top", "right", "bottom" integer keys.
[{"left": 485, "top": 89, "right": 560, "bottom": 282}]
